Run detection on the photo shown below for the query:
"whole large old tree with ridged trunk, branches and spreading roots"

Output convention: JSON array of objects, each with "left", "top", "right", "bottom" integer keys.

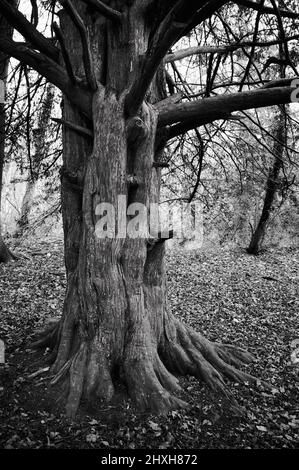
[{"left": 0, "top": 0, "right": 299, "bottom": 416}]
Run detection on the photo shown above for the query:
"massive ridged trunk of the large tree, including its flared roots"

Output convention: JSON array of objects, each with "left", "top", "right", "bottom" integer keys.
[{"left": 35, "top": 2, "right": 255, "bottom": 416}]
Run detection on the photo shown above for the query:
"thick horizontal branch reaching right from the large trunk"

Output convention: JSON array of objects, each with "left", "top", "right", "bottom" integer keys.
[{"left": 159, "top": 87, "right": 294, "bottom": 126}]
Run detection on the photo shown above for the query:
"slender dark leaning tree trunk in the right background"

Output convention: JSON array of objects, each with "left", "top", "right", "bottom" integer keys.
[{"left": 247, "top": 107, "right": 287, "bottom": 255}]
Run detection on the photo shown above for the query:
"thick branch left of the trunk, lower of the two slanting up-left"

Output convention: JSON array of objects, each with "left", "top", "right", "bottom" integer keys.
[{"left": 0, "top": 37, "right": 91, "bottom": 118}]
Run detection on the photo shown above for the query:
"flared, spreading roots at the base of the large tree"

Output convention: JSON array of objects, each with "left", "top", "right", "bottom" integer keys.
[{"left": 32, "top": 316, "right": 270, "bottom": 417}]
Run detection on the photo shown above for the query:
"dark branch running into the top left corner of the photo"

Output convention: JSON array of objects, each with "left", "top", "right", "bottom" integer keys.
[{"left": 0, "top": 0, "right": 59, "bottom": 61}]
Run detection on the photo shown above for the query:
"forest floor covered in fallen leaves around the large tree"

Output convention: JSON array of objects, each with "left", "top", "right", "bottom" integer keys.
[{"left": 0, "top": 240, "right": 299, "bottom": 449}]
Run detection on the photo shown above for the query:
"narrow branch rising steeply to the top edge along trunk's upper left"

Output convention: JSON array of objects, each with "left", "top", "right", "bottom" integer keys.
[{"left": 59, "top": 0, "right": 98, "bottom": 91}]
